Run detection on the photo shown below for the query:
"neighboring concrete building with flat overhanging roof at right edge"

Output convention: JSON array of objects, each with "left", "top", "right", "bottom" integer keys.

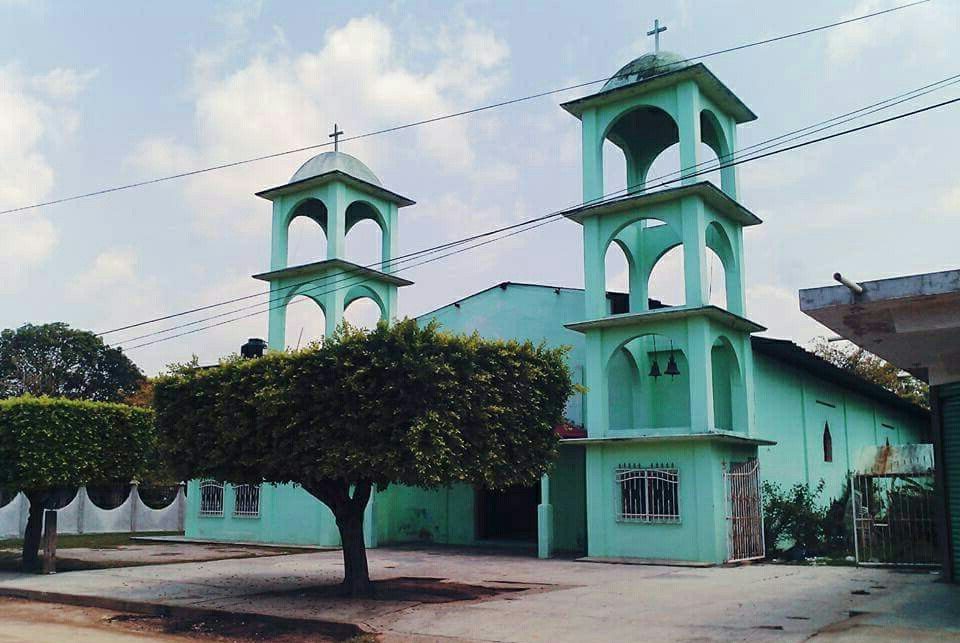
[{"left": 800, "top": 270, "right": 960, "bottom": 580}]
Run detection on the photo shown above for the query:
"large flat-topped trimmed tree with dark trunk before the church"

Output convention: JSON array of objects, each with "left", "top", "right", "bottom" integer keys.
[{"left": 154, "top": 320, "right": 573, "bottom": 596}]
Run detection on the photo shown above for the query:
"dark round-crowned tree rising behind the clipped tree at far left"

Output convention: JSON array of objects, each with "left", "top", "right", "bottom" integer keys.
[{"left": 0, "top": 323, "right": 143, "bottom": 402}]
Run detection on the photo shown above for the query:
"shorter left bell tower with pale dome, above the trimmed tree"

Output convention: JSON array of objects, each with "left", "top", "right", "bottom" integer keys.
[{"left": 254, "top": 142, "right": 414, "bottom": 350}]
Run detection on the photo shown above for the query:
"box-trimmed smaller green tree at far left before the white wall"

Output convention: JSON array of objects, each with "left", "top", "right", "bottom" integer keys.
[{"left": 0, "top": 397, "right": 157, "bottom": 571}]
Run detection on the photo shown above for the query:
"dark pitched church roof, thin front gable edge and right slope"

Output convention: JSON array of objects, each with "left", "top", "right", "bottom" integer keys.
[{"left": 418, "top": 281, "right": 930, "bottom": 420}]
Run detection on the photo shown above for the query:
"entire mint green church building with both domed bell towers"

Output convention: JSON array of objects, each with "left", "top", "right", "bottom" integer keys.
[{"left": 186, "top": 47, "right": 929, "bottom": 564}]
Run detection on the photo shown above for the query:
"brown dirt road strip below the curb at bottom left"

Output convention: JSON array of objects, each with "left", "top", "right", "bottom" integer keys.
[{"left": 0, "top": 598, "right": 377, "bottom": 643}]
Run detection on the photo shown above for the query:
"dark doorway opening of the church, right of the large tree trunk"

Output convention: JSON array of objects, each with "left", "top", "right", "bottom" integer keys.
[{"left": 477, "top": 482, "right": 540, "bottom": 542}]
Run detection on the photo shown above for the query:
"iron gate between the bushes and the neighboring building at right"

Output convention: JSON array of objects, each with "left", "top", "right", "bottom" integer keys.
[{"left": 850, "top": 474, "right": 940, "bottom": 566}]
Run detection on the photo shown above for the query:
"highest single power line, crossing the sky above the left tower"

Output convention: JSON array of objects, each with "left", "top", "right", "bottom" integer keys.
[{"left": 0, "top": 0, "right": 930, "bottom": 215}]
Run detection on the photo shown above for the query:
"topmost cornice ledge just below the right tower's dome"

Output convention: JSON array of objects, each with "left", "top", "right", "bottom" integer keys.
[{"left": 560, "top": 63, "right": 757, "bottom": 123}]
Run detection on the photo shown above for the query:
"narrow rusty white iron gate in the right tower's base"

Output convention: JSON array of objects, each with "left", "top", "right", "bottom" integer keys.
[{"left": 723, "top": 459, "right": 766, "bottom": 563}]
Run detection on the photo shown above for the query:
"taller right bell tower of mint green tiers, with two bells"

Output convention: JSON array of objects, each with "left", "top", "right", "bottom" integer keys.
[{"left": 562, "top": 30, "right": 771, "bottom": 562}]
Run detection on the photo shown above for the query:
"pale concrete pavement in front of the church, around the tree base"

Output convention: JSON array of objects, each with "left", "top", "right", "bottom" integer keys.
[{"left": 0, "top": 548, "right": 960, "bottom": 641}]
